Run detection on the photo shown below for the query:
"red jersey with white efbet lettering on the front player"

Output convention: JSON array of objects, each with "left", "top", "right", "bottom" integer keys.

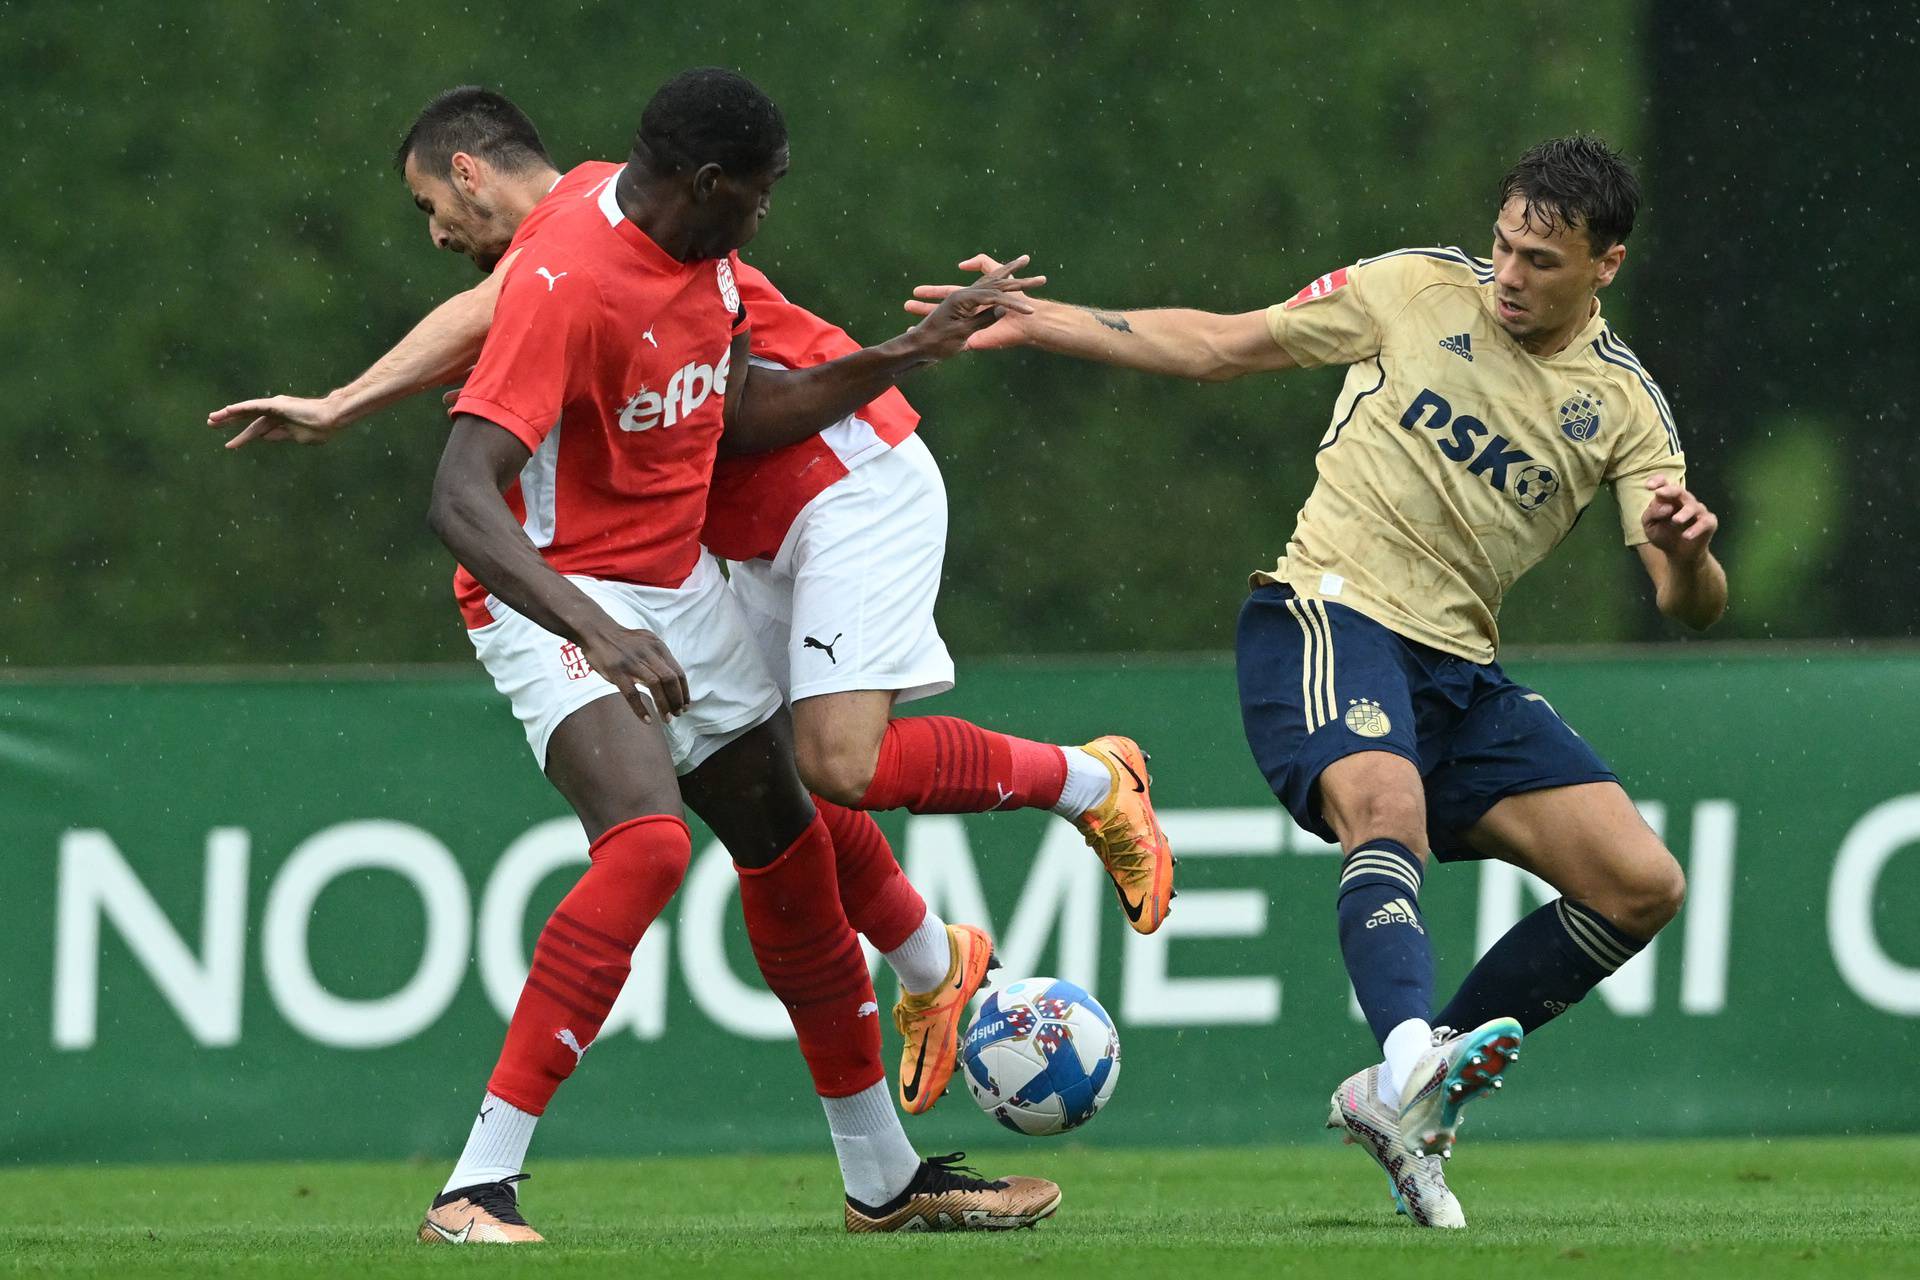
[{"left": 453, "top": 167, "right": 747, "bottom": 626}]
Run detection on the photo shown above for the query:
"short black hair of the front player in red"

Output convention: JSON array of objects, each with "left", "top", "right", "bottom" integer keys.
[{"left": 634, "top": 67, "right": 787, "bottom": 177}]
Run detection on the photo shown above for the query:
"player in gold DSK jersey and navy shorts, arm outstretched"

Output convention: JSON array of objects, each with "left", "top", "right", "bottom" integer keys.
[{"left": 908, "top": 136, "right": 1726, "bottom": 1226}]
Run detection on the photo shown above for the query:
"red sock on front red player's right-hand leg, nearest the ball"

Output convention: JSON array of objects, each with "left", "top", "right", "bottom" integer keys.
[{"left": 739, "top": 816, "right": 885, "bottom": 1098}]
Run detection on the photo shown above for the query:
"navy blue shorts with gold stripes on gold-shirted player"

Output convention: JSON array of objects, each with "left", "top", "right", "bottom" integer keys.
[{"left": 1235, "top": 585, "right": 1617, "bottom": 862}]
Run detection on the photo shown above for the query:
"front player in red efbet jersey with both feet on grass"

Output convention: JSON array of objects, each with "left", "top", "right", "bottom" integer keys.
[{"left": 234, "top": 69, "right": 1060, "bottom": 1244}]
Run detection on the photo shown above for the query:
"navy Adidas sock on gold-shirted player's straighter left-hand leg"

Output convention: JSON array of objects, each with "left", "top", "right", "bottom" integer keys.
[{"left": 1340, "top": 839, "right": 1434, "bottom": 1046}]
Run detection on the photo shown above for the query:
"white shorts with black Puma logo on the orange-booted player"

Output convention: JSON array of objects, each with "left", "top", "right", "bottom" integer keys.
[{"left": 728, "top": 436, "right": 954, "bottom": 702}]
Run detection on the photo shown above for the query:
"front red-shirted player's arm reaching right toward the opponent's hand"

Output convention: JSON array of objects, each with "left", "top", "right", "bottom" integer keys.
[{"left": 720, "top": 257, "right": 1046, "bottom": 455}]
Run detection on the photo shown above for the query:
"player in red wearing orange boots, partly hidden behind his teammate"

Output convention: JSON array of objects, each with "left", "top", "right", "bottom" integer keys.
[{"left": 209, "top": 86, "right": 1173, "bottom": 1113}]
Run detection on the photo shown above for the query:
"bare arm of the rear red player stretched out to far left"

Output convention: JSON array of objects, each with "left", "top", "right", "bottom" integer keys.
[{"left": 207, "top": 253, "right": 516, "bottom": 449}]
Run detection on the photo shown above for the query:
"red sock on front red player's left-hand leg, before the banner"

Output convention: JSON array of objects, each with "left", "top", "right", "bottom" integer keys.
[{"left": 488, "top": 814, "right": 693, "bottom": 1115}]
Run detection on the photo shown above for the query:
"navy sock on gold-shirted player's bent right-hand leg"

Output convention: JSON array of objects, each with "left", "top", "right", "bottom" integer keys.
[{"left": 1443, "top": 898, "right": 1645, "bottom": 1034}]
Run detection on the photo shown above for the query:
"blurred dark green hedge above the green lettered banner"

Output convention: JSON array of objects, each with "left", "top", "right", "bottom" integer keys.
[{"left": 0, "top": 0, "right": 1920, "bottom": 666}]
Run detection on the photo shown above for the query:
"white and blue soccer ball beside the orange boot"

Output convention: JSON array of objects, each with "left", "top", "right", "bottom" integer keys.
[{"left": 960, "top": 979, "right": 1119, "bottom": 1138}]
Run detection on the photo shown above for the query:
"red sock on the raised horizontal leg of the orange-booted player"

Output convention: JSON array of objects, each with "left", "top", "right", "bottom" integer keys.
[{"left": 858, "top": 716, "right": 1068, "bottom": 814}]
